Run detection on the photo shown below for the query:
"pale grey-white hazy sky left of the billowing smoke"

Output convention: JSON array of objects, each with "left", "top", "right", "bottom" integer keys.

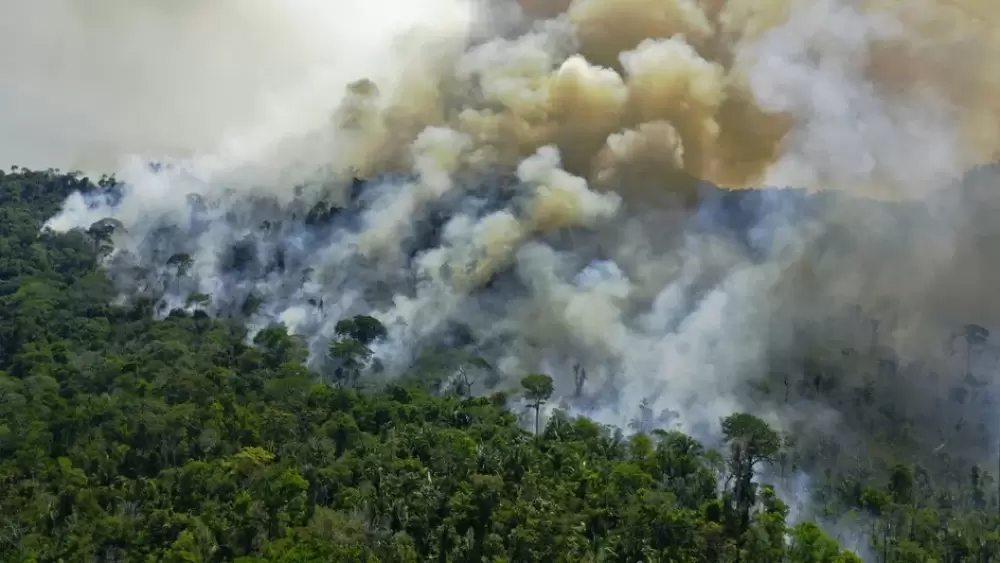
[{"left": 0, "top": 0, "right": 471, "bottom": 171}]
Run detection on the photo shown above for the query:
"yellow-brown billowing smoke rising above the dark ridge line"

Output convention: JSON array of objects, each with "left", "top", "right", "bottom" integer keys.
[{"left": 334, "top": 0, "right": 1000, "bottom": 205}]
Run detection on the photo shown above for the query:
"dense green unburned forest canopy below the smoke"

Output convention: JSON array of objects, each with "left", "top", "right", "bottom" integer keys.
[{"left": 0, "top": 171, "right": 1000, "bottom": 563}]
